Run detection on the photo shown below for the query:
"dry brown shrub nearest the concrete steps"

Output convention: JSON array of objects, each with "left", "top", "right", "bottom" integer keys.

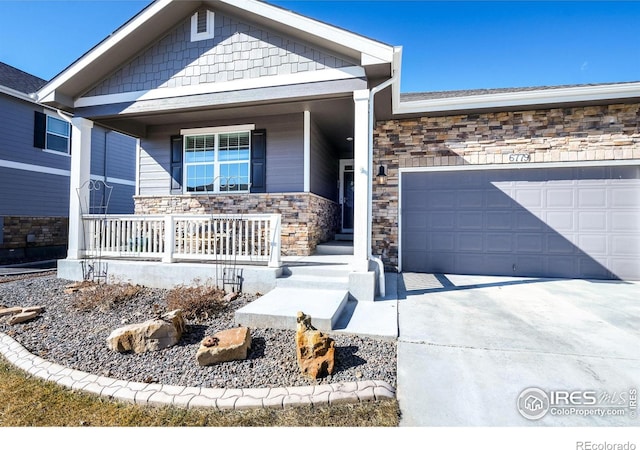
[{"left": 166, "top": 280, "right": 228, "bottom": 320}]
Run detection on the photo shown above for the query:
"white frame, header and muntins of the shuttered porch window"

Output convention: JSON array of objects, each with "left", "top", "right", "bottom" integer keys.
[{"left": 180, "top": 124, "right": 255, "bottom": 195}]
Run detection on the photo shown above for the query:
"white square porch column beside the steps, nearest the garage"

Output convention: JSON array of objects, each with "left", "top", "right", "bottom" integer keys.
[{"left": 353, "top": 89, "right": 371, "bottom": 272}]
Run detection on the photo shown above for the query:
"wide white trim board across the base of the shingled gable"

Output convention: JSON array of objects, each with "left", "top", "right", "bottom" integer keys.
[{"left": 74, "top": 66, "right": 365, "bottom": 108}]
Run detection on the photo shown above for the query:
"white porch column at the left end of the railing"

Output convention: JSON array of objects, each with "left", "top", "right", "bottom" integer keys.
[{"left": 67, "top": 117, "right": 93, "bottom": 259}]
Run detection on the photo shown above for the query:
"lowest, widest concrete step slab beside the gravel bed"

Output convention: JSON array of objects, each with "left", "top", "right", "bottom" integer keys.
[{"left": 235, "top": 287, "right": 349, "bottom": 331}]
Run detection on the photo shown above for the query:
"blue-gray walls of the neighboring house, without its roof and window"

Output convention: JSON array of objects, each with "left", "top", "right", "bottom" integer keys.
[{"left": 0, "top": 89, "right": 136, "bottom": 263}]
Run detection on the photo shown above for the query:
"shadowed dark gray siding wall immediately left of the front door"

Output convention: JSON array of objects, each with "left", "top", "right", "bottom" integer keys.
[{"left": 311, "top": 120, "right": 340, "bottom": 201}]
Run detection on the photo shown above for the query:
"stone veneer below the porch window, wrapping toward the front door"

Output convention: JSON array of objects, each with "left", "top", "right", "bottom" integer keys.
[{"left": 134, "top": 193, "right": 340, "bottom": 256}]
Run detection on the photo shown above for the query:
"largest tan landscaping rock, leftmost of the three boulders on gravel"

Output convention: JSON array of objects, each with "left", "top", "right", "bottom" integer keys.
[{"left": 107, "top": 309, "right": 185, "bottom": 353}]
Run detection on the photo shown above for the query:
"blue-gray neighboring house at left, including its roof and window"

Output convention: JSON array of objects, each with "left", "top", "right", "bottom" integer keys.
[{"left": 0, "top": 63, "right": 135, "bottom": 264}]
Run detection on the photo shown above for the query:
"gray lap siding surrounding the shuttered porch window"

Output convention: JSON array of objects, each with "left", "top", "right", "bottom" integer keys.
[{"left": 140, "top": 114, "right": 304, "bottom": 195}]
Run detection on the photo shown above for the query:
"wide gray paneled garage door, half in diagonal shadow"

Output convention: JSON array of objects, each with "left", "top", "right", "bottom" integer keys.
[{"left": 401, "top": 166, "right": 640, "bottom": 280}]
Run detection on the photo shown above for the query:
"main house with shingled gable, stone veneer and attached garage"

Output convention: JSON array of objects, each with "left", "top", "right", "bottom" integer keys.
[{"left": 37, "top": 0, "right": 640, "bottom": 292}]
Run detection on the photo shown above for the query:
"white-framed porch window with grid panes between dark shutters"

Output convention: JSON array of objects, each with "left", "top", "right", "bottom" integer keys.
[{"left": 184, "top": 131, "right": 251, "bottom": 193}]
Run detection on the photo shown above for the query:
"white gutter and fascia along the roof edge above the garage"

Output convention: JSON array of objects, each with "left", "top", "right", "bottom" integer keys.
[{"left": 393, "top": 82, "right": 640, "bottom": 115}]
